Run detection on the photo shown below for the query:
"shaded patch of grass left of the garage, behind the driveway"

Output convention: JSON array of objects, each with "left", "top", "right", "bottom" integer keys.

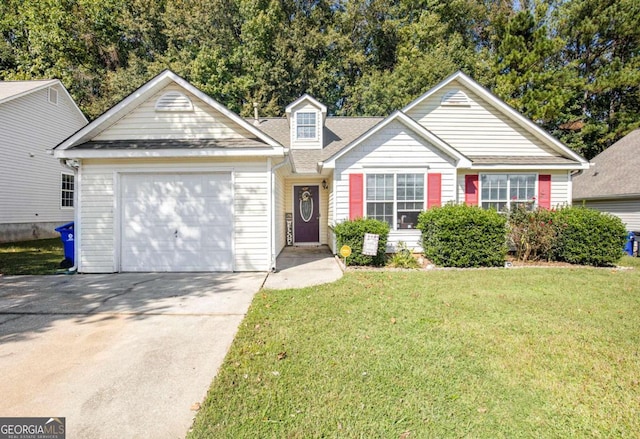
[{"left": 0, "top": 238, "right": 64, "bottom": 275}]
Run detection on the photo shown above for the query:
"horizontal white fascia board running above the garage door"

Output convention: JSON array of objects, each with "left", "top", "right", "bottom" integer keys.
[{"left": 53, "top": 147, "right": 285, "bottom": 159}]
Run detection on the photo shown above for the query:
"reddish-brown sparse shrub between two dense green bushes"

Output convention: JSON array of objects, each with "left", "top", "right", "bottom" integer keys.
[{"left": 507, "top": 204, "right": 556, "bottom": 261}]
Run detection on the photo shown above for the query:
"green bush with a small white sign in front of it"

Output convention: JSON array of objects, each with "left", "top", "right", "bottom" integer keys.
[{"left": 333, "top": 218, "right": 389, "bottom": 266}]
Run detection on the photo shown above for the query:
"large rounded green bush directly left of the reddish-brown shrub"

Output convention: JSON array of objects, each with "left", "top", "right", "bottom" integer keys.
[{"left": 418, "top": 204, "right": 507, "bottom": 267}]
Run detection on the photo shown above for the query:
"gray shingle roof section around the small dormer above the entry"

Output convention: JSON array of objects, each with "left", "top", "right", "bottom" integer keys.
[{"left": 254, "top": 117, "right": 383, "bottom": 173}]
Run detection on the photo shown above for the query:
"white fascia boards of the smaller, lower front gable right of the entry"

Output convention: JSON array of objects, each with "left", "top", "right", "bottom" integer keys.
[{"left": 323, "top": 111, "right": 471, "bottom": 169}]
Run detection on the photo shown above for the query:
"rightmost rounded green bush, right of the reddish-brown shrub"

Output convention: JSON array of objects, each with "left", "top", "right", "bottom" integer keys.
[{"left": 554, "top": 206, "right": 626, "bottom": 267}]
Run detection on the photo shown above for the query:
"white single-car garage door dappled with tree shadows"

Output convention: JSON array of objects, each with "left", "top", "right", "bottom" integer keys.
[{"left": 121, "top": 173, "right": 233, "bottom": 271}]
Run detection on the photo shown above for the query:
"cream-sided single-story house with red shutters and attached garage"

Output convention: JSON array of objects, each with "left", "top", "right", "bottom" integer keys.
[{"left": 55, "top": 71, "right": 589, "bottom": 272}]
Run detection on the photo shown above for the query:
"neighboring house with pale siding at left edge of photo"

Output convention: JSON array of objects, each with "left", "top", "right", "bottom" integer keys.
[{"left": 0, "top": 79, "right": 87, "bottom": 242}]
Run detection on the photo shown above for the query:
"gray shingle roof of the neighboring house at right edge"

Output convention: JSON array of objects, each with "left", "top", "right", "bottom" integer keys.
[{"left": 573, "top": 129, "right": 640, "bottom": 200}]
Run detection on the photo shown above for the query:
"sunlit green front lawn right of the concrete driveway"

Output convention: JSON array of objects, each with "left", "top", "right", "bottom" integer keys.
[{"left": 189, "top": 268, "right": 640, "bottom": 438}]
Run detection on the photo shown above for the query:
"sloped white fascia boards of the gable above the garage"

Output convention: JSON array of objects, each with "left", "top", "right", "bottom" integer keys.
[{"left": 54, "top": 70, "right": 280, "bottom": 150}]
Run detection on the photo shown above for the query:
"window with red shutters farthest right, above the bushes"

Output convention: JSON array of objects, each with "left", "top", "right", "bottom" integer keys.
[{"left": 480, "top": 174, "right": 536, "bottom": 211}]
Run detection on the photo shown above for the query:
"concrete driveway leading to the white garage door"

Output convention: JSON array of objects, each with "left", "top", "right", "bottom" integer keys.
[{"left": 0, "top": 273, "right": 265, "bottom": 438}]
